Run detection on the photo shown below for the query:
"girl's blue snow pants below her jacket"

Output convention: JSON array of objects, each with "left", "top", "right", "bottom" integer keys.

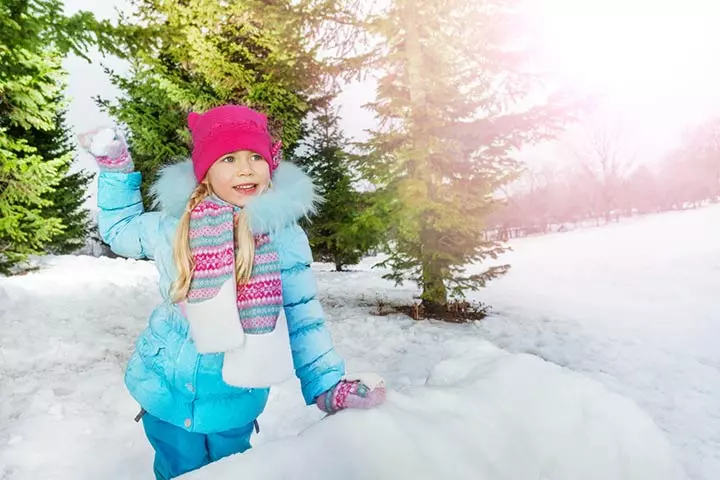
[{"left": 142, "top": 413, "right": 253, "bottom": 480}]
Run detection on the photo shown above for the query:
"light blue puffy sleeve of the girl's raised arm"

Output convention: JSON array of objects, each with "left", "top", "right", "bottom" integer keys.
[{"left": 98, "top": 172, "right": 161, "bottom": 259}]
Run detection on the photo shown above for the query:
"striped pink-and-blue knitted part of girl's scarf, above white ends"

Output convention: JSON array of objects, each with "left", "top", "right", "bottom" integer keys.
[{"left": 188, "top": 195, "right": 283, "bottom": 335}]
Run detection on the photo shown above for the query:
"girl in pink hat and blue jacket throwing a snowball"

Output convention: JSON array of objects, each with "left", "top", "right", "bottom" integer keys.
[{"left": 80, "top": 105, "right": 385, "bottom": 480}]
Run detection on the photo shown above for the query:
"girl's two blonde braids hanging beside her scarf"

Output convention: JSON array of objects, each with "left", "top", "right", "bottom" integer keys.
[{"left": 170, "top": 181, "right": 255, "bottom": 302}]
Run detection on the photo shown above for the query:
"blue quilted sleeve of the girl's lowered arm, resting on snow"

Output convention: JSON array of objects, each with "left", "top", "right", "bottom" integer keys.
[{"left": 280, "top": 225, "right": 345, "bottom": 405}]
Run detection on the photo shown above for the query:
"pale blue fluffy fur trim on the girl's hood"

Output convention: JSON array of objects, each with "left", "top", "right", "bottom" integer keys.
[{"left": 151, "top": 160, "right": 321, "bottom": 233}]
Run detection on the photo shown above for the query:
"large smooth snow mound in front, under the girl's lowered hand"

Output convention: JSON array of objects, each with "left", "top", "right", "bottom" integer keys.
[{"left": 182, "top": 342, "right": 684, "bottom": 480}]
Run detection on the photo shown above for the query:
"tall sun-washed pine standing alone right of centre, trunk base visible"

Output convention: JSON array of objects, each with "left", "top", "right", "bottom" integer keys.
[{"left": 366, "top": 0, "right": 576, "bottom": 314}]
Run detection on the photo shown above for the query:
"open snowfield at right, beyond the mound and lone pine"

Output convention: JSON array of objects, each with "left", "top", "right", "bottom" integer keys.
[{"left": 477, "top": 206, "right": 720, "bottom": 480}]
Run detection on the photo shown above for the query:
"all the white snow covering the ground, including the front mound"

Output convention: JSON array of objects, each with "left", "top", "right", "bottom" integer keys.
[{"left": 0, "top": 208, "right": 720, "bottom": 480}]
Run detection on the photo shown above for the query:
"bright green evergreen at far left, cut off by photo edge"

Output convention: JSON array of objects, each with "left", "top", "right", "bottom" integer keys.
[{"left": 0, "top": 0, "right": 126, "bottom": 274}]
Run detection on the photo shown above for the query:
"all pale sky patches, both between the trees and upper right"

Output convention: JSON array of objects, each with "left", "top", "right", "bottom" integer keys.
[{"left": 65, "top": 0, "right": 720, "bottom": 178}]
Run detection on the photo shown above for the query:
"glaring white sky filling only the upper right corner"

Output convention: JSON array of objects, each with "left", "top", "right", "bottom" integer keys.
[{"left": 527, "top": 0, "right": 720, "bottom": 171}]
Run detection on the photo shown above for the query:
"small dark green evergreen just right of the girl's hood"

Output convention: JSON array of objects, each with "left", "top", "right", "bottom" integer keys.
[{"left": 297, "top": 105, "right": 384, "bottom": 271}]
